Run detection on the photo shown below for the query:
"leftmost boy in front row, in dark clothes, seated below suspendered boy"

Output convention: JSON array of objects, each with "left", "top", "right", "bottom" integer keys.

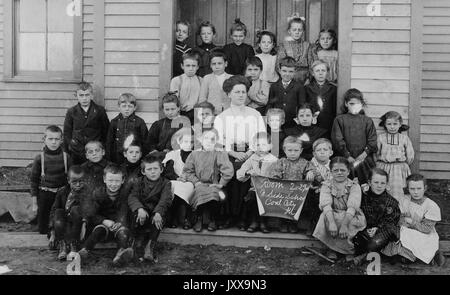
[{"left": 49, "top": 165, "right": 87, "bottom": 260}]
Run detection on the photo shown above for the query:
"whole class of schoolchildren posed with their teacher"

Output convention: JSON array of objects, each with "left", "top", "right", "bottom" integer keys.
[{"left": 27, "top": 14, "right": 440, "bottom": 265}]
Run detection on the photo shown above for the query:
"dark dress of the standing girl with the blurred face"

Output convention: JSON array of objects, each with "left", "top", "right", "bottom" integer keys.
[{"left": 331, "top": 113, "right": 378, "bottom": 184}]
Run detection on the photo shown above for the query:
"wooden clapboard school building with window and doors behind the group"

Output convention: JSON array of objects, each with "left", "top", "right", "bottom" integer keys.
[{"left": 0, "top": 0, "right": 450, "bottom": 179}]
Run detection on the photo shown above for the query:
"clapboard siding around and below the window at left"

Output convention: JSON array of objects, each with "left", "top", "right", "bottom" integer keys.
[{"left": 0, "top": 0, "right": 80, "bottom": 166}]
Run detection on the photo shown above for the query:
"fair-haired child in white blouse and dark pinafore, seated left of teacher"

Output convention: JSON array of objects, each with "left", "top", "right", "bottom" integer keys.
[{"left": 163, "top": 128, "right": 194, "bottom": 229}]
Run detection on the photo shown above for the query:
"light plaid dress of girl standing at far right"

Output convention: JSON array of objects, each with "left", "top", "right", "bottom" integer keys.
[{"left": 376, "top": 132, "right": 414, "bottom": 200}]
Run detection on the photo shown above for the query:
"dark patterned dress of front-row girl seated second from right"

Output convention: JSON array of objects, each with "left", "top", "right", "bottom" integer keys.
[{"left": 353, "top": 189, "right": 401, "bottom": 254}]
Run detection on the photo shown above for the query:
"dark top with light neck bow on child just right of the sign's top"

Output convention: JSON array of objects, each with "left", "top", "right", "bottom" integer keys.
[{"left": 286, "top": 125, "right": 327, "bottom": 161}]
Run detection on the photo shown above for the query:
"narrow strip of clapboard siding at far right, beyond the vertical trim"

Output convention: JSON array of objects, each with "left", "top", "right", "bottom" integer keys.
[{"left": 420, "top": 0, "right": 450, "bottom": 179}]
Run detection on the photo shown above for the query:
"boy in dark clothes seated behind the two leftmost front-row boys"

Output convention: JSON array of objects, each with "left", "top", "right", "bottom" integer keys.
[{"left": 81, "top": 140, "right": 110, "bottom": 189}]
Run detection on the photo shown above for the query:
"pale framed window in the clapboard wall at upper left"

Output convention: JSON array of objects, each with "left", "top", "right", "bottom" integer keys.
[{"left": 4, "top": 0, "right": 82, "bottom": 82}]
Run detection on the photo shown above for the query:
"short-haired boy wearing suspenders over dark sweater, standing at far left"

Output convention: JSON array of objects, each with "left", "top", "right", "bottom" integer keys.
[{"left": 30, "top": 125, "right": 72, "bottom": 234}]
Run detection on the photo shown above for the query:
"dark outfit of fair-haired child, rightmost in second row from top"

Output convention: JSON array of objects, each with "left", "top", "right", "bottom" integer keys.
[{"left": 305, "top": 79, "right": 337, "bottom": 134}]
